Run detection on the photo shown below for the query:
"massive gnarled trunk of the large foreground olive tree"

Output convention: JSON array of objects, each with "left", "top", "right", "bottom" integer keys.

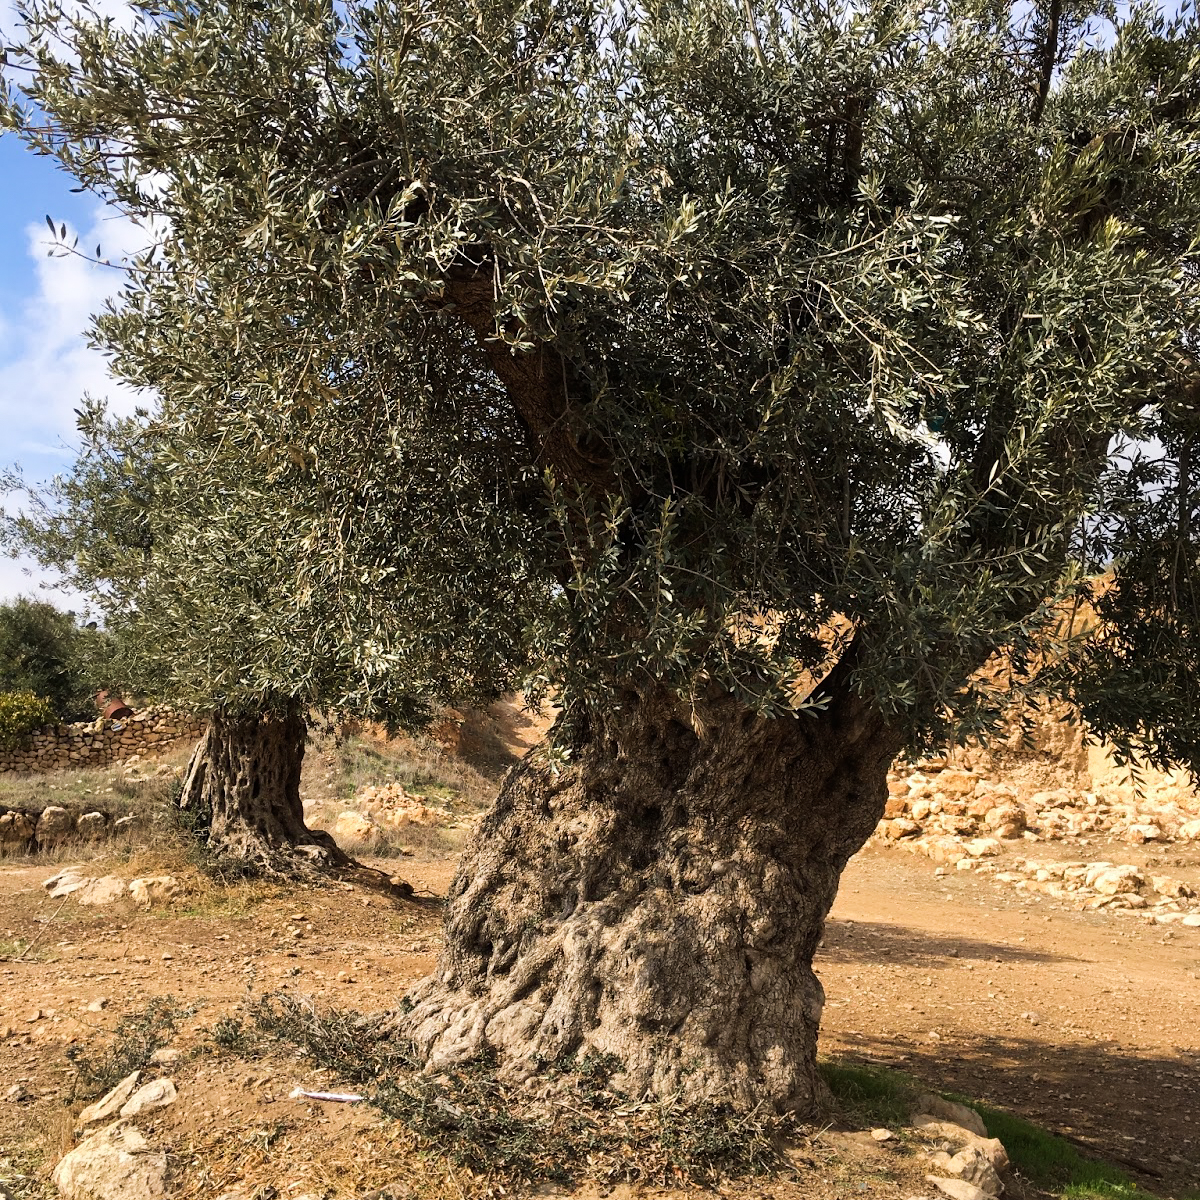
[{"left": 397, "top": 692, "right": 898, "bottom": 1111}]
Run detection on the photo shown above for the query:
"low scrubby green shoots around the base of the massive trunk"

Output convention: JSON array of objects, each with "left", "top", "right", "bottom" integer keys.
[{"left": 237, "top": 995, "right": 790, "bottom": 1187}]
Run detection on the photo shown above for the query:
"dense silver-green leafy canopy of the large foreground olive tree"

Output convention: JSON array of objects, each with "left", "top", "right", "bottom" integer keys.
[{"left": 4, "top": 0, "right": 1200, "bottom": 761}]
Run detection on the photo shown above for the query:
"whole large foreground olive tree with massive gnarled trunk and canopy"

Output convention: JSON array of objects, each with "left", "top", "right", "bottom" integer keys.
[{"left": 6, "top": 0, "right": 1200, "bottom": 1109}]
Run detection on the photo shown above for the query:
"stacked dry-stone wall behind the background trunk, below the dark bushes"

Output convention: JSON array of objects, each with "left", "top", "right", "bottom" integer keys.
[{"left": 0, "top": 706, "right": 204, "bottom": 773}]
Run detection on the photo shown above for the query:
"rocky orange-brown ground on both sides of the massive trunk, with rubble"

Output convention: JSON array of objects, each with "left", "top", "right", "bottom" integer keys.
[{"left": 0, "top": 712, "right": 1200, "bottom": 1200}]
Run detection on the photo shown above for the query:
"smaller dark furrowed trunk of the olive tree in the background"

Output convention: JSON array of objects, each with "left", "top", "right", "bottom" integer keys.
[{"left": 180, "top": 706, "right": 350, "bottom": 874}]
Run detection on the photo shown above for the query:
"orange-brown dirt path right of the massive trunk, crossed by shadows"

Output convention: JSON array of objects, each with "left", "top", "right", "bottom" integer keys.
[{"left": 817, "top": 847, "right": 1200, "bottom": 1192}]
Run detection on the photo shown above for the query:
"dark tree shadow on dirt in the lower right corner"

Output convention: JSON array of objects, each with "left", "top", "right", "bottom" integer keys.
[{"left": 822, "top": 1032, "right": 1200, "bottom": 1196}]
